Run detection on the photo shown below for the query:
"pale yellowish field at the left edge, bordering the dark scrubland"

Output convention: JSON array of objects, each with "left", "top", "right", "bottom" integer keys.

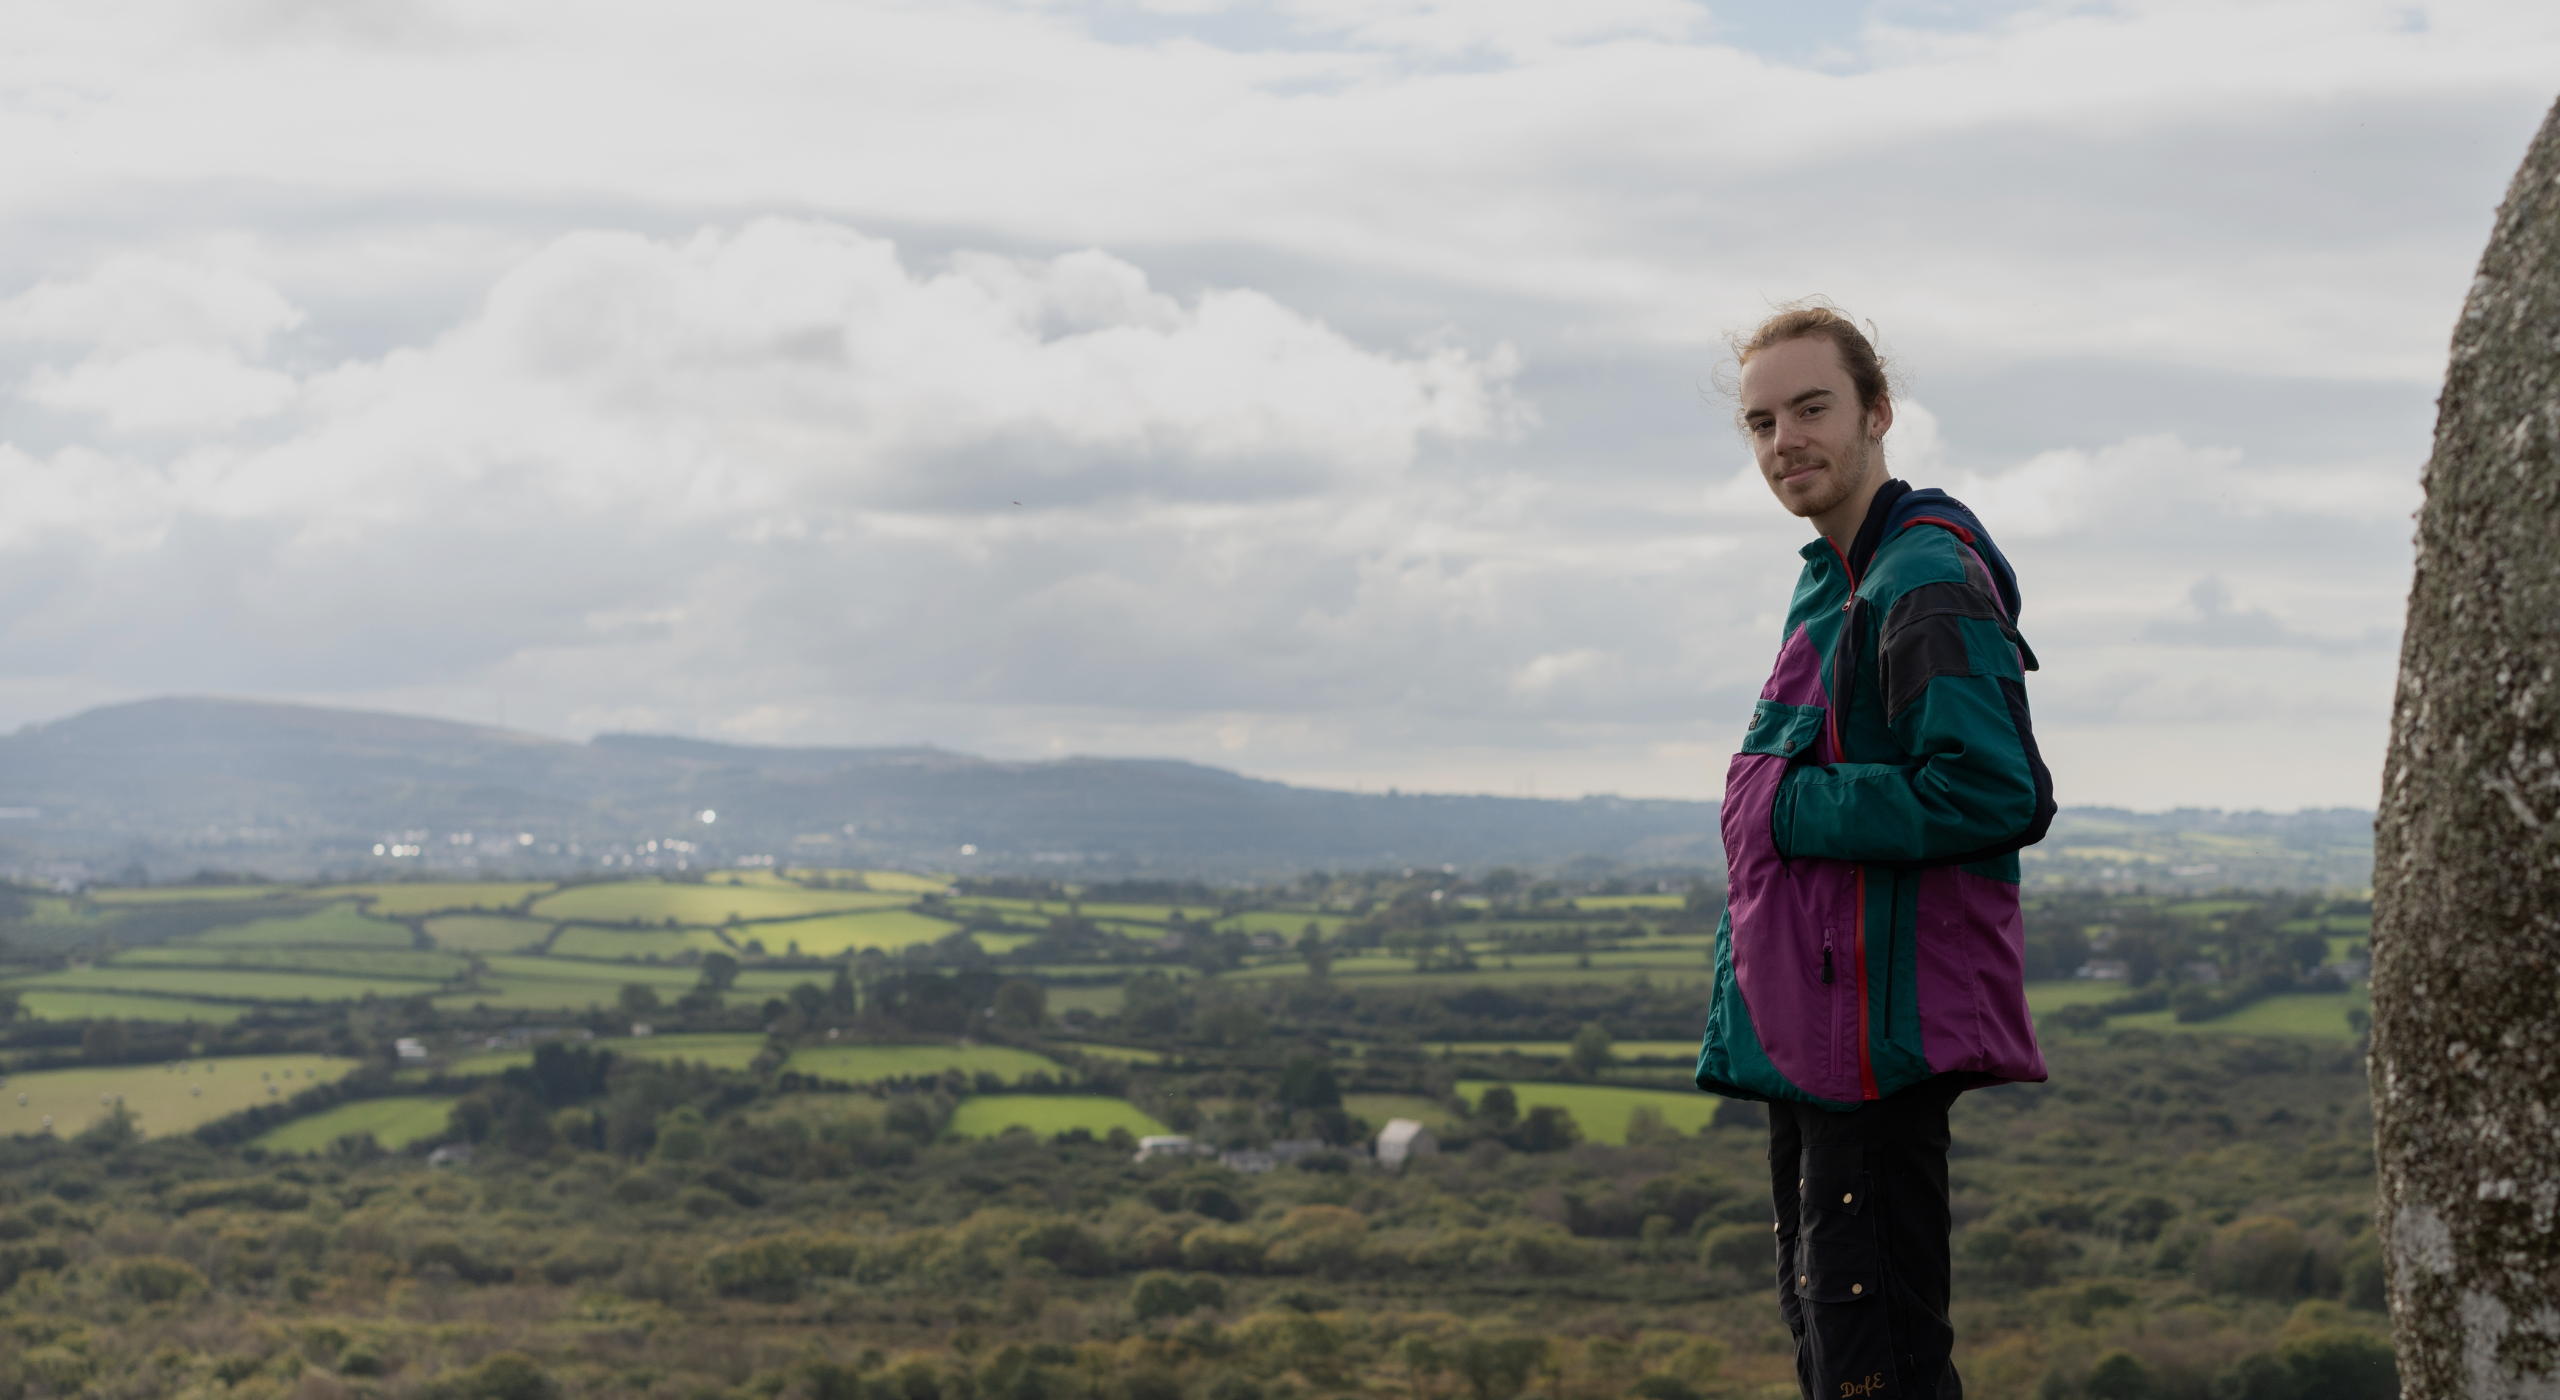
[{"left": 0, "top": 1054, "right": 356, "bottom": 1136}]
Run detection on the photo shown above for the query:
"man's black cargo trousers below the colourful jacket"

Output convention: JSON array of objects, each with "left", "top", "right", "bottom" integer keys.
[{"left": 1769, "top": 1075, "right": 1964, "bottom": 1400}]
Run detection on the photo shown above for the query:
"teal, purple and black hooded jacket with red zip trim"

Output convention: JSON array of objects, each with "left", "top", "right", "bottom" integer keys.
[{"left": 1697, "top": 481, "right": 2053, "bottom": 1111}]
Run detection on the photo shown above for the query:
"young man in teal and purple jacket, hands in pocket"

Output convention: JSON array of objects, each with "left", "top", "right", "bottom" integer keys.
[{"left": 1697, "top": 305, "right": 2053, "bottom": 1400}]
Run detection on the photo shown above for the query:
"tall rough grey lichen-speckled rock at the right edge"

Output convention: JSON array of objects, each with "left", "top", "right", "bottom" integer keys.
[{"left": 2368, "top": 93, "right": 2560, "bottom": 1400}]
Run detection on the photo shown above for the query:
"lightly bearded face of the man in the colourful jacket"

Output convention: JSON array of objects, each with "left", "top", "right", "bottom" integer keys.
[{"left": 1741, "top": 335, "right": 1894, "bottom": 520}]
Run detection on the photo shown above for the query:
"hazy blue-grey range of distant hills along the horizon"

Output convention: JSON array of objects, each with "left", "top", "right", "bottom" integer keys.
[{"left": 0, "top": 699, "right": 2373, "bottom": 891}]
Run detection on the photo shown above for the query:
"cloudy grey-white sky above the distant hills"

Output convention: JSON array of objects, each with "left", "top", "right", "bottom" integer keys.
[{"left": 0, "top": 0, "right": 2560, "bottom": 811}]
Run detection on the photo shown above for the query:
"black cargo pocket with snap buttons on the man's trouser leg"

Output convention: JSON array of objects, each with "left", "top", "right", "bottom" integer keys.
[{"left": 1792, "top": 1152, "right": 1902, "bottom": 1400}]
